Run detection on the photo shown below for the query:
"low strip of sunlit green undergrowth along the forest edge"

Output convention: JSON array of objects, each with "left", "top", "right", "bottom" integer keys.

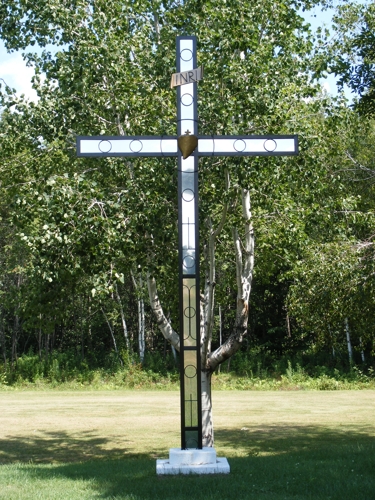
[{"left": 0, "top": 349, "right": 375, "bottom": 390}]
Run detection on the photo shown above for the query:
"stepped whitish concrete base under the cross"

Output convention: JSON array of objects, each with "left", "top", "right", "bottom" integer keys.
[{"left": 156, "top": 448, "right": 230, "bottom": 474}]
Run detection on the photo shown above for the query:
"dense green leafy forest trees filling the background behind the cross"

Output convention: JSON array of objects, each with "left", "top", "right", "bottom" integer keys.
[{"left": 0, "top": 0, "right": 375, "bottom": 388}]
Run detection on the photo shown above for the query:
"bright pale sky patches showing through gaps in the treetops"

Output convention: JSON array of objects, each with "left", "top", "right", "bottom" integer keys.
[{"left": 0, "top": 5, "right": 356, "bottom": 100}]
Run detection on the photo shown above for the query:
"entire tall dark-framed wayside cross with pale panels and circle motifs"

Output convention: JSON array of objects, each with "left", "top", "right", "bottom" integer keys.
[{"left": 77, "top": 36, "right": 298, "bottom": 449}]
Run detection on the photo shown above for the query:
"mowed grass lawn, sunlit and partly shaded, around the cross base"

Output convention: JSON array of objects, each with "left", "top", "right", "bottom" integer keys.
[{"left": 0, "top": 391, "right": 375, "bottom": 500}]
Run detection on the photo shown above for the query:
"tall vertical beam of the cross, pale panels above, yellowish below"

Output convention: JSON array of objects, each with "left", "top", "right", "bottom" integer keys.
[{"left": 176, "top": 36, "right": 202, "bottom": 449}]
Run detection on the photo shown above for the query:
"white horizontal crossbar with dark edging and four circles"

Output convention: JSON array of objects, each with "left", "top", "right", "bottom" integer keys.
[{"left": 77, "top": 135, "right": 298, "bottom": 157}]
